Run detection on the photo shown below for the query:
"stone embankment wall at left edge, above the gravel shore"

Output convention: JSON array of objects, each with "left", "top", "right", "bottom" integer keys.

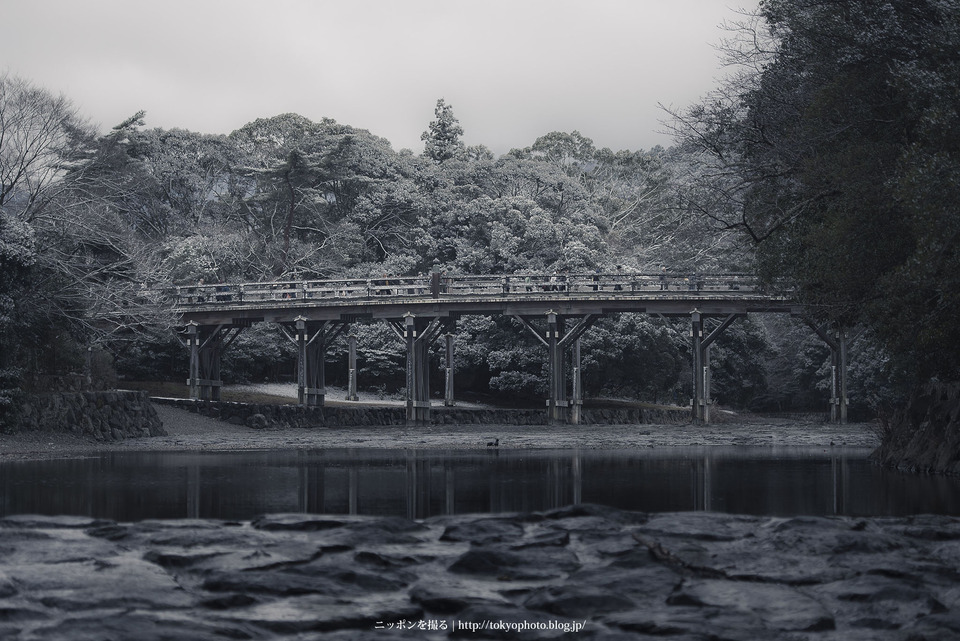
[{"left": 6, "top": 391, "right": 166, "bottom": 441}]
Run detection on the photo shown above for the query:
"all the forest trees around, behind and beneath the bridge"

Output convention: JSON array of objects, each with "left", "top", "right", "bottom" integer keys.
[{"left": 0, "top": 0, "right": 960, "bottom": 424}]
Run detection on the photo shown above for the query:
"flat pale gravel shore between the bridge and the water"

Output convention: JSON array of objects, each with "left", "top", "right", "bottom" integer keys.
[{"left": 0, "top": 405, "right": 878, "bottom": 460}]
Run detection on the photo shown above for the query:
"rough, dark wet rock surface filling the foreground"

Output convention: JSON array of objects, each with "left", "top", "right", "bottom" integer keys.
[{"left": 0, "top": 506, "right": 960, "bottom": 641}]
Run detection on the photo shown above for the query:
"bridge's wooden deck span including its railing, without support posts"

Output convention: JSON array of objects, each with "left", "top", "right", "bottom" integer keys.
[{"left": 175, "top": 274, "right": 799, "bottom": 325}]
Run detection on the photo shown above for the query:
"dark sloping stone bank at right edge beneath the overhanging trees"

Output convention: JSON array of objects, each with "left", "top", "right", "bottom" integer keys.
[{"left": 871, "top": 383, "right": 960, "bottom": 475}]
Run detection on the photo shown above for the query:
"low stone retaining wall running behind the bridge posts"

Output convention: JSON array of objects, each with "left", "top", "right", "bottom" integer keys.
[{"left": 153, "top": 398, "right": 690, "bottom": 428}]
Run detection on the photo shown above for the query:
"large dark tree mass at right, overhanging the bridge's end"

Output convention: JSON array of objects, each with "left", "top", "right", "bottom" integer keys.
[{"left": 675, "top": 0, "right": 960, "bottom": 379}]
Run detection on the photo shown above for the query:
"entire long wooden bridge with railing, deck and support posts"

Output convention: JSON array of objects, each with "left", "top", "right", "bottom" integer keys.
[{"left": 176, "top": 272, "right": 860, "bottom": 423}]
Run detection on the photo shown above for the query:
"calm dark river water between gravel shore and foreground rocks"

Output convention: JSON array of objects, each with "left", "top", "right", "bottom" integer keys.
[{"left": 0, "top": 447, "right": 960, "bottom": 521}]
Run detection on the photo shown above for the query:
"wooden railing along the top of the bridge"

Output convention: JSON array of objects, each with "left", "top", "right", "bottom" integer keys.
[{"left": 174, "top": 272, "right": 760, "bottom": 307}]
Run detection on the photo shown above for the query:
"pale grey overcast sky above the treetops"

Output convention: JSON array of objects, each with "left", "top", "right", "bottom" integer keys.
[{"left": 0, "top": 0, "right": 757, "bottom": 154}]
